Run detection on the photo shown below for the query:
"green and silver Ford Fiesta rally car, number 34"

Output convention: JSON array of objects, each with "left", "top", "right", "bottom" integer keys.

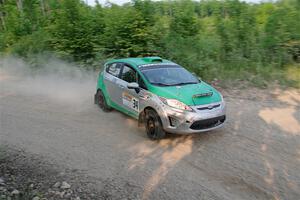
[{"left": 95, "top": 57, "right": 226, "bottom": 139}]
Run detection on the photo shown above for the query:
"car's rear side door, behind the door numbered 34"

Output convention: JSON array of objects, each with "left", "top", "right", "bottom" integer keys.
[{"left": 104, "top": 63, "right": 123, "bottom": 106}]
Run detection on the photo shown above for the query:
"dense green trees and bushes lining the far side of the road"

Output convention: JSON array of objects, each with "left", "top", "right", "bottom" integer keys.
[{"left": 0, "top": 0, "right": 300, "bottom": 88}]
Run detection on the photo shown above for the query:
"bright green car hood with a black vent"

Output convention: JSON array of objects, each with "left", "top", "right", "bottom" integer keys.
[{"left": 151, "top": 81, "right": 222, "bottom": 106}]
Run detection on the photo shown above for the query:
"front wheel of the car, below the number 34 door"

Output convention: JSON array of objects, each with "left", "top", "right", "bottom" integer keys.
[{"left": 145, "top": 109, "right": 166, "bottom": 140}]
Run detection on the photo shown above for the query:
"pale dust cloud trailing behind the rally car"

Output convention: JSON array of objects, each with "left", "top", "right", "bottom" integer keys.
[{"left": 0, "top": 57, "right": 98, "bottom": 105}]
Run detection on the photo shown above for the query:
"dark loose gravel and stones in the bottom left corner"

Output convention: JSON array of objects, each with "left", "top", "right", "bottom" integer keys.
[{"left": 0, "top": 145, "right": 103, "bottom": 200}]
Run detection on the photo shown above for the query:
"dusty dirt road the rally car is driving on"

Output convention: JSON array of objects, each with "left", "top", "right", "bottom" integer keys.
[{"left": 0, "top": 61, "right": 300, "bottom": 200}]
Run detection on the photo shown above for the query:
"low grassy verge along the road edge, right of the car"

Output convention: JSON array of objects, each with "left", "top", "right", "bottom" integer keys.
[{"left": 201, "top": 63, "right": 300, "bottom": 88}]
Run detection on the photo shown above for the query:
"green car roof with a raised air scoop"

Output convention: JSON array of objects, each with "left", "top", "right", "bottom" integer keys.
[{"left": 107, "top": 56, "right": 176, "bottom": 69}]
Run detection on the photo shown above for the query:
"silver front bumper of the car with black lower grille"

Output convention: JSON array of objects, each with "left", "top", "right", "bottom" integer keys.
[{"left": 158, "top": 101, "right": 226, "bottom": 134}]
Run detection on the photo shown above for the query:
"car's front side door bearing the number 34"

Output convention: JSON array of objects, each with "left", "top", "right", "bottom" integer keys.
[{"left": 120, "top": 64, "right": 145, "bottom": 116}]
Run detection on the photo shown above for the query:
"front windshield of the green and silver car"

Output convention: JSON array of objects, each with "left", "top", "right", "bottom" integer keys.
[{"left": 141, "top": 65, "right": 199, "bottom": 86}]
